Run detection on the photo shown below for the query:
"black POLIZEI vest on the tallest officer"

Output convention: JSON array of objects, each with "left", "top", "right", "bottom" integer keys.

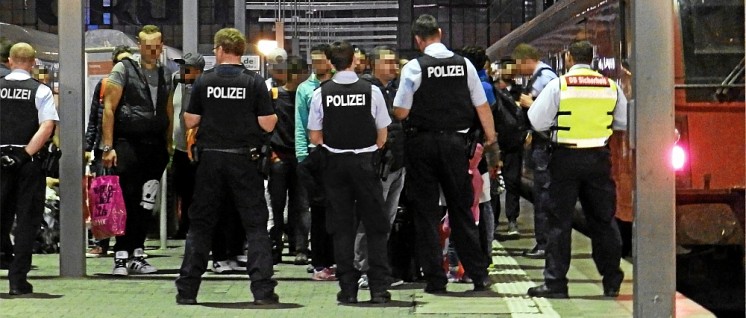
[{"left": 409, "top": 55, "right": 475, "bottom": 131}]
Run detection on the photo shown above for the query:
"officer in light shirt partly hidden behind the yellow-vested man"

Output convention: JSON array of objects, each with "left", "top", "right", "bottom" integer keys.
[{"left": 506, "top": 43, "right": 557, "bottom": 258}]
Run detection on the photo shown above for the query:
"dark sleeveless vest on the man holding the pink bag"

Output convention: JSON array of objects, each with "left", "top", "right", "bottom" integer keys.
[{"left": 114, "top": 59, "right": 169, "bottom": 141}]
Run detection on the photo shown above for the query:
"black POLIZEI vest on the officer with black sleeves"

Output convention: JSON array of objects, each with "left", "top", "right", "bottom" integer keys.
[{"left": 193, "top": 65, "right": 269, "bottom": 149}]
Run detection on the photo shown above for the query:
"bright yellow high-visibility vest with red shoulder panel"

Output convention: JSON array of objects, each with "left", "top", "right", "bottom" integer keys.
[{"left": 552, "top": 68, "right": 617, "bottom": 148}]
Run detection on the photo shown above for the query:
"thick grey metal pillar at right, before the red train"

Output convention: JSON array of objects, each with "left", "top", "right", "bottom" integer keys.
[{"left": 631, "top": 0, "right": 676, "bottom": 317}]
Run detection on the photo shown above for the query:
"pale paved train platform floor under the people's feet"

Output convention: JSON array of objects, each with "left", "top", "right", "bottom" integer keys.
[{"left": 0, "top": 204, "right": 714, "bottom": 318}]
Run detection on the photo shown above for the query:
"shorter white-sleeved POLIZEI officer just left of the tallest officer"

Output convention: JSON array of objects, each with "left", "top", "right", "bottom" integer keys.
[{"left": 308, "top": 41, "right": 391, "bottom": 303}]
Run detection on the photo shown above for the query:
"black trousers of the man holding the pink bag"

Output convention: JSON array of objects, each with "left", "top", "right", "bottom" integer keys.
[{"left": 114, "top": 139, "right": 168, "bottom": 256}]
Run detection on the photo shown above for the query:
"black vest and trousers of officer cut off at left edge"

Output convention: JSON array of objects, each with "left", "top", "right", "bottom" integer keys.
[{"left": 0, "top": 78, "right": 45, "bottom": 294}]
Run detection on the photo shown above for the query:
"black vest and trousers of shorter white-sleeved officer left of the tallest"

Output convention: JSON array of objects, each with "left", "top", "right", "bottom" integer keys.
[{"left": 321, "top": 80, "right": 391, "bottom": 299}]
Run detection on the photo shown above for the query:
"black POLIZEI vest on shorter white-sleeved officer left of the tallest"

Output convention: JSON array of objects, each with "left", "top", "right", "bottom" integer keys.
[{"left": 321, "top": 80, "right": 377, "bottom": 149}]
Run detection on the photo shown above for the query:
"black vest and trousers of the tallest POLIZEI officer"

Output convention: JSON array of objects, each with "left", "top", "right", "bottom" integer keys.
[{"left": 405, "top": 55, "right": 488, "bottom": 292}]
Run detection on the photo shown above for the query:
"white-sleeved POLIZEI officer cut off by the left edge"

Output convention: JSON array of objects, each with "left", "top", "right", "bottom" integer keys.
[{"left": 0, "top": 42, "right": 59, "bottom": 295}]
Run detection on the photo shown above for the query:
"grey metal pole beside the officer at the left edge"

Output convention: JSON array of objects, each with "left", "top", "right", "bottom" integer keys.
[{"left": 57, "top": 0, "right": 86, "bottom": 277}]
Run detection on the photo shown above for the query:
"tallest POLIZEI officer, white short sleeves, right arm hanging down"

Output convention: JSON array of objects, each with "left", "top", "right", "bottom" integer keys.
[{"left": 394, "top": 14, "right": 496, "bottom": 294}]
